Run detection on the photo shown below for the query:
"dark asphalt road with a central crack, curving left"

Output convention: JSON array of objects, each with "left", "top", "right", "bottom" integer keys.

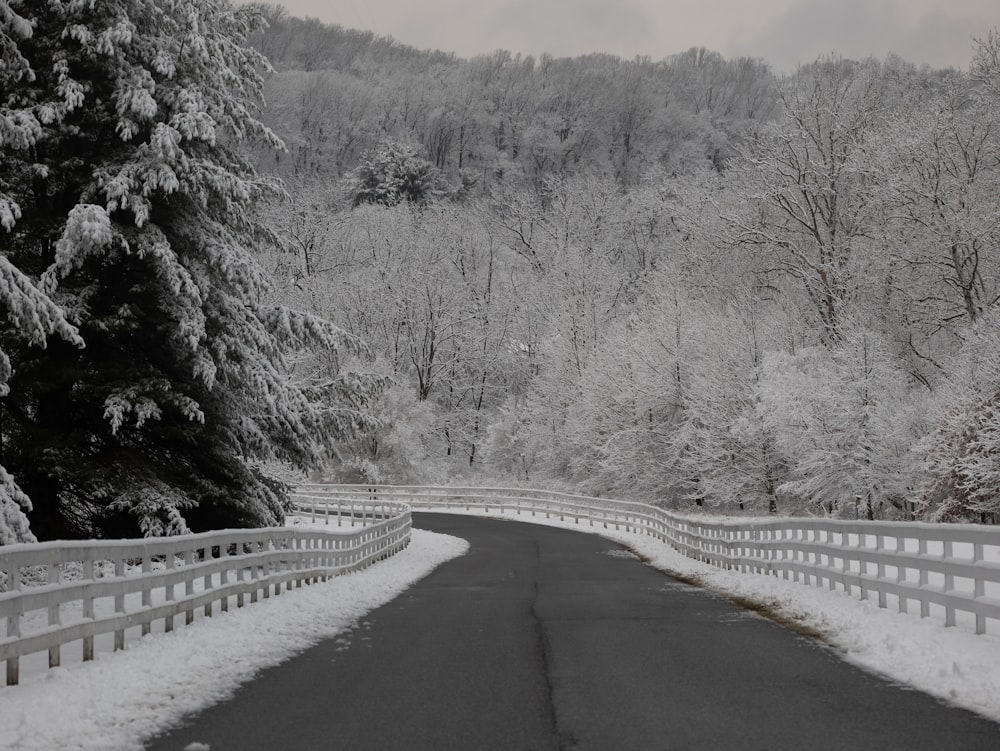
[{"left": 147, "top": 514, "right": 1000, "bottom": 751}]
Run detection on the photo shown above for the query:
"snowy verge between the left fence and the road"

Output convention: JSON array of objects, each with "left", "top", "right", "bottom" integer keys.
[{"left": 0, "top": 529, "right": 469, "bottom": 751}]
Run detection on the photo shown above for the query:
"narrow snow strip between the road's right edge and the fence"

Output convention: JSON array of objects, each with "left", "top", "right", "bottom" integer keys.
[{"left": 428, "top": 509, "right": 1000, "bottom": 722}]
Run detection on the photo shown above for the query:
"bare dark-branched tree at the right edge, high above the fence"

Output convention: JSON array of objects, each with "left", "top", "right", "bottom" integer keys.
[{"left": 879, "top": 75, "right": 1000, "bottom": 328}]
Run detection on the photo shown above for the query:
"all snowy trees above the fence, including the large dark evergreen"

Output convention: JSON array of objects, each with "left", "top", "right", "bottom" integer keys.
[{"left": 0, "top": 0, "right": 1000, "bottom": 544}]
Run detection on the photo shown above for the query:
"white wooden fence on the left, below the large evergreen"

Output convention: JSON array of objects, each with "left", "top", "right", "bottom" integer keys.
[{"left": 0, "top": 500, "right": 411, "bottom": 685}]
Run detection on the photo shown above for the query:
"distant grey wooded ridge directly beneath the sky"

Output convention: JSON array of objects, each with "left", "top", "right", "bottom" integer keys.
[{"left": 255, "top": 6, "right": 777, "bottom": 189}]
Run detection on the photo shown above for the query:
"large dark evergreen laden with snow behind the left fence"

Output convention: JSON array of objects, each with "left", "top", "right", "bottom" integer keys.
[{"left": 0, "top": 0, "right": 382, "bottom": 537}]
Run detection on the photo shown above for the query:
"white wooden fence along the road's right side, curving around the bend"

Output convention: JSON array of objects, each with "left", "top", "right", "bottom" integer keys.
[{"left": 297, "top": 485, "right": 1000, "bottom": 634}]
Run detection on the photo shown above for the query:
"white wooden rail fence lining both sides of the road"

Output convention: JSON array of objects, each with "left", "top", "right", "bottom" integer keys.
[{"left": 0, "top": 485, "right": 1000, "bottom": 685}]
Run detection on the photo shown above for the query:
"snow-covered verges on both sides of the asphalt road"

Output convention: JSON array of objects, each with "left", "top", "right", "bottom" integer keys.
[{"left": 0, "top": 512, "right": 1000, "bottom": 751}]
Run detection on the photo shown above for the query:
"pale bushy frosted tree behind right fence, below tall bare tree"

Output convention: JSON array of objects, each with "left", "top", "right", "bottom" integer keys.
[{"left": 760, "top": 322, "right": 919, "bottom": 519}]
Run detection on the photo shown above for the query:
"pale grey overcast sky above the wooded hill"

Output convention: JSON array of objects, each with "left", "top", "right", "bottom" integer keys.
[{"left": 252, "top": 0, "right": 1000, "bottom": 71}]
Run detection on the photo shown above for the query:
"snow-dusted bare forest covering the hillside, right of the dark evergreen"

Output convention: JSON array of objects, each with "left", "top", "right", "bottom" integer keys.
[{"left": 246, "top": 6, "right": 1000, "bottom": 521}]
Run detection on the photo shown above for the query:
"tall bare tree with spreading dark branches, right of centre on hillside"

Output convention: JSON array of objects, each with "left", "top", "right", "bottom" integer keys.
[{"left": 731, "top": 58, "right": 884, "bottom": 343}]
